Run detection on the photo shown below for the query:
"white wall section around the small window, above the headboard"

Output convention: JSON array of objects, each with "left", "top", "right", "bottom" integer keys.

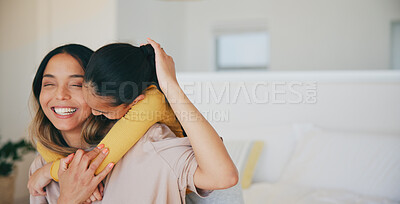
[{"left": 184, "top": 0, "right": 400, "bottom": 71}]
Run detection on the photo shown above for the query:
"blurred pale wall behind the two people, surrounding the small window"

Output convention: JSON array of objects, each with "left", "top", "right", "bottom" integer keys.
[{"left": 0, "top": 0, "right": 400, "bottom": 203}]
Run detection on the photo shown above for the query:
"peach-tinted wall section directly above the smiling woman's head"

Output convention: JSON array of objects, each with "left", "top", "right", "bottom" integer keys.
[{"left": 37, "top": 0, "right": 117, "bottom": 56}]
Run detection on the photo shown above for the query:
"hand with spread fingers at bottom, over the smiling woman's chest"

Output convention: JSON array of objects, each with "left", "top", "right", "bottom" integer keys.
[{"left": 58, "top": 148, "right": 114, "bottom": 204}]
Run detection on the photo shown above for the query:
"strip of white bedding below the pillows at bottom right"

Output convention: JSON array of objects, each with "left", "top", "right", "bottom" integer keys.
[{"left": 243, "top": 183, "right": 400, "bottom": 204}]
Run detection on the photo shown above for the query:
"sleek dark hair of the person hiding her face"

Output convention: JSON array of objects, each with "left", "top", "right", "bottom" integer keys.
[{"left": 84, "top": 43, "right": 161, "bottom": 106}]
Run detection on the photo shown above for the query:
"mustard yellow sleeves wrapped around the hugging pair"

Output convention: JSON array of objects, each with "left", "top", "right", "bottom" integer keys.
[{"left": 37, "top": 85, "right": 183, "bottom": 181}]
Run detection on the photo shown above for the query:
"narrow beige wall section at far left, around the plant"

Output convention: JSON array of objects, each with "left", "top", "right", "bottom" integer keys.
[{"left": 0, "top": 1, "right": 37, "bottom": 203}]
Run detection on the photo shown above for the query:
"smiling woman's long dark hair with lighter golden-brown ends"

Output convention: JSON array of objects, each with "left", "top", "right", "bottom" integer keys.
[{"left": 30, "top": 44, "right": 111, "bottom": 156}]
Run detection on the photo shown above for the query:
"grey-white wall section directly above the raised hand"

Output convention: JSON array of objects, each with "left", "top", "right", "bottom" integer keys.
[{"left": 117, "top": 0, "right": 185, "bottom": 71}]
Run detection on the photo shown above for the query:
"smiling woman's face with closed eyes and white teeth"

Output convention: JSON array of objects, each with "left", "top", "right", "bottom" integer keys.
[{"left": 39, "top": 53, "right": 91, "bottom": 132}]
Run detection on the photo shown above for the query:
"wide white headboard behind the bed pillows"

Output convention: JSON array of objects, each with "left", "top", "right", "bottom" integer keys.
[{"left": 177, "top": 70, "right": 400, "bottom": 135}]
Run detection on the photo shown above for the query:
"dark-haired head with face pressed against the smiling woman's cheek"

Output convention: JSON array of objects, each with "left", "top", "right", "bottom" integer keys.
[{"left": 83, "top": 43, "right": 158, "bottom": 119}]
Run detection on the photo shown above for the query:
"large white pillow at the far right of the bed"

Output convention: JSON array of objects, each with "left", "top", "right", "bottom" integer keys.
[{"left": 282, "top": 129, "right": 400, "bottom": 201}]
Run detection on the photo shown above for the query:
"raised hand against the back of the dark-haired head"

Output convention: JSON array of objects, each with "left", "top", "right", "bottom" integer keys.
[{"left": 147, "top": 38, "right": 178, "bottom": 93}]
